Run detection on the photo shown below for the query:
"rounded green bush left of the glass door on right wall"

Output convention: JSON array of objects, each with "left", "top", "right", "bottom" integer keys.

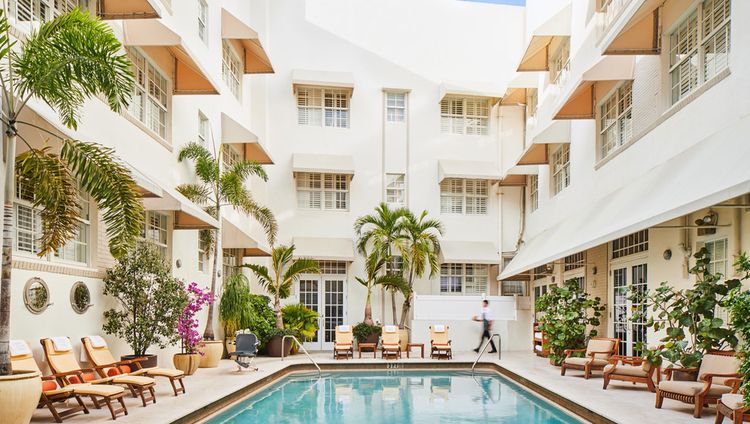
[{"left": 536, "top": 280, "right": 606, "bottom": 365}]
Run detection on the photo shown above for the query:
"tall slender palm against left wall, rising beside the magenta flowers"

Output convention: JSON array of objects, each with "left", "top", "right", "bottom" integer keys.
[{"left": 177, "top": 142, "right": 278, "bottom": 340}]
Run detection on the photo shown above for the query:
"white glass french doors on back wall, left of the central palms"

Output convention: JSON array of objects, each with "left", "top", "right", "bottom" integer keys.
[{"left": 299, "top": 277, "right": 346, "bottom": 350}]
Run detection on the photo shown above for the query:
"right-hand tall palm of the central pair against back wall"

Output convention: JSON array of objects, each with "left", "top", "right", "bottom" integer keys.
[{"left": 399, "top": 211, "right": 443, "bottom": 328}]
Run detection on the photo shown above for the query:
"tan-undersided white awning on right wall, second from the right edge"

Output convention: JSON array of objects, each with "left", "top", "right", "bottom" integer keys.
[{"left": 553, "top": 56, "right": 635, "bottom": 119}]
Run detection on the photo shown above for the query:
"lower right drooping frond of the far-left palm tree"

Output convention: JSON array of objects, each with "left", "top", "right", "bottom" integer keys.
[{"left": 60, "top": 140, "right": 144, "bottom": 258}]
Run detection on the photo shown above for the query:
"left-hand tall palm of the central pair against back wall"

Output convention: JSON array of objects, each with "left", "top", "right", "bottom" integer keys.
[{"left": 354, "top": 202, "right": 409, "bottom": 325}]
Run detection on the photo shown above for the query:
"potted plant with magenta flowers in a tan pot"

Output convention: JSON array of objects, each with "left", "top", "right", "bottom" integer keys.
[{"left": 172, "top": 282, "right": 214, "bottom": 375}]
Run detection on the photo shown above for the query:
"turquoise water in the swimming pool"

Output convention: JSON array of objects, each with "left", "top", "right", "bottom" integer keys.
[{"left": 208, "top": 371, "right": 581, "bottom": 424}]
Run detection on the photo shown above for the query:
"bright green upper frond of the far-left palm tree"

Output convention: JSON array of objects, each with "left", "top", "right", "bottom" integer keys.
[{"left": 11, "top": 9, "right": 135, "bottom": 128}]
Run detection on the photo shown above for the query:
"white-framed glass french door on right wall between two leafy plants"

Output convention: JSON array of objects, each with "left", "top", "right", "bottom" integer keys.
[{"left": 610, "top": 262, "right": 648, "bottom": 356}]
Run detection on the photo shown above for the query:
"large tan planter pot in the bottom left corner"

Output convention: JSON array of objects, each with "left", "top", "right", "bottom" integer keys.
[{"left": 0, "top": 371, "right": 42, "bottom": 424}]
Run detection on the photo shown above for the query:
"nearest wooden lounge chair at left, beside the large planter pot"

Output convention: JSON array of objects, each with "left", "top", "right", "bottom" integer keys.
[{"left": 10, "top": 340, "right": 128, "bottom": 423}]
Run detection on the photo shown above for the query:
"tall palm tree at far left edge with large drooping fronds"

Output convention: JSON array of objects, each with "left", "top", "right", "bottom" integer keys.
[{"left": 0, "top": 9, "right": 144, "bottom": 375}]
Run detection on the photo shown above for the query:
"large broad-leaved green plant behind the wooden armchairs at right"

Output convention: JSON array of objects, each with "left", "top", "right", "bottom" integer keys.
[{"left": 629, "top": 248, "right": 742, "bottom": 368}]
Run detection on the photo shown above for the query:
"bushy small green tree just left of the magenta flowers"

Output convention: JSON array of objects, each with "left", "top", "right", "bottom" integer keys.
[{"left": 103, "top": 243, "right": 188, "bottom": 356}]
